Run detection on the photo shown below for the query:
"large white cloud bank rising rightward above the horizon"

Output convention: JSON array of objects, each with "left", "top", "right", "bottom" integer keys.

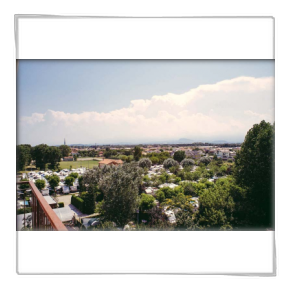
[{"left": 19, "top": 77, "right": 274, "bottom": 144}]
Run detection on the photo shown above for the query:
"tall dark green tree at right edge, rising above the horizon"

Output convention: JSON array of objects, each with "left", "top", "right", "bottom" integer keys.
[{"left": 233, "top": 120, "right": 275, "bottom": 228}]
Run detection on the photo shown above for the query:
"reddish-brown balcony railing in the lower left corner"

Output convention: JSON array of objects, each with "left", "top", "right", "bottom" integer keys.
[{"left": 16, "top": 181, "right": 67, "bottom": 231}]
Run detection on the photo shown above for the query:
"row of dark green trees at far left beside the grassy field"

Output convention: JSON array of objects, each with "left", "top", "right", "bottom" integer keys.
[{"left": 16, "top": 144, "right": 71, "bottom": 171}]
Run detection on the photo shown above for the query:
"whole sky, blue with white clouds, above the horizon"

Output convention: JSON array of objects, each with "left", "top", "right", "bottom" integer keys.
[{"left": 17, "top": 60, "right": 275, "bottom": 146}]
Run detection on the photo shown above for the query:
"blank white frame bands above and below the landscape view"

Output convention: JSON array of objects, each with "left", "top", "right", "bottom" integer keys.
[{"left": 15, "top": 15, "right": 276, "bottom": 276}]
